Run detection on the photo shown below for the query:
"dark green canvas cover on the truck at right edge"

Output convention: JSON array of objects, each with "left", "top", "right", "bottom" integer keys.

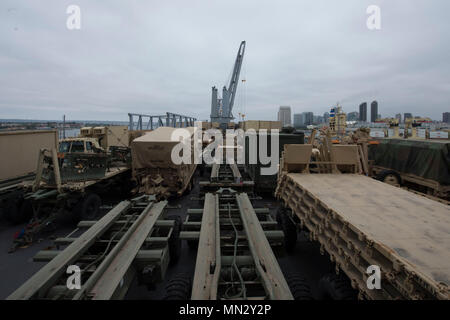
[{"left": 369, "top": 139, "right": 450, "bottom": 185}]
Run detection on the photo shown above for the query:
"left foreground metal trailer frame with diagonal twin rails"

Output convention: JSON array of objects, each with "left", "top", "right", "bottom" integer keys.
[{"left": 8, "top": 196, "right": 179, "bottom": 300}]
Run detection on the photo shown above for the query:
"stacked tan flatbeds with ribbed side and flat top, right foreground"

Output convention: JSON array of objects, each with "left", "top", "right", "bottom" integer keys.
[{"left": 276, "top": 172, "right": 450, "bottom": 299}]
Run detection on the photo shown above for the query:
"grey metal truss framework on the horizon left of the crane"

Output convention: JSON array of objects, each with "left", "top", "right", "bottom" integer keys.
[{"left": 128, "top": 112, "right": 197, "bottom": 130}]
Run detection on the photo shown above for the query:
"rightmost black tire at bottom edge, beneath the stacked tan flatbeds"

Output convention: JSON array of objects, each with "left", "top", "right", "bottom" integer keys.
[{"left": 319, "top": 273, "right": 357, "bottom": 300}]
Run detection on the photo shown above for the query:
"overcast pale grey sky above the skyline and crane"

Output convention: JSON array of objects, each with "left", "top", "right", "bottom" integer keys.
[{"left": 0, "top": 0, "right": 450, "bottom": 121}]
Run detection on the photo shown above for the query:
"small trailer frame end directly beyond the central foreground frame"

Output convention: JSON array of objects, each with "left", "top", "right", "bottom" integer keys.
[{"left": 199, "top": 163, "right": 254, "bottom": 192}]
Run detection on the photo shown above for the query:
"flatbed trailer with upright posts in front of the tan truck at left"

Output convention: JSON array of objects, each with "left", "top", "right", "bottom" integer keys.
[{"left": 9, "top": 149, "right": 131, "bottom": 252}]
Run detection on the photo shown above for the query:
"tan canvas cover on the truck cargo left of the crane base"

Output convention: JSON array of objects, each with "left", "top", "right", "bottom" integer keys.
[{"left": 131, "top": 127, "right": 194, "bottom": 172}]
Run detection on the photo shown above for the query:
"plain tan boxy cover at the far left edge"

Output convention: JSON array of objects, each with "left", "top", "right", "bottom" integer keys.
[{"left": 0, "top": 130, "right": 58, "bottom": 181}]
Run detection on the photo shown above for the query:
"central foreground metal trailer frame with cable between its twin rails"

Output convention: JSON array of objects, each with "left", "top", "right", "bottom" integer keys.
[{"left": 180, "top": 189, "right": 293, "bottom": 300}]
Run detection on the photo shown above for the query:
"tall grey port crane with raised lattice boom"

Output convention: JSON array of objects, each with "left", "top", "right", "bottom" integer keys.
[{"left": 211, "top": 41, "right": 245, "bottom": 127}]
